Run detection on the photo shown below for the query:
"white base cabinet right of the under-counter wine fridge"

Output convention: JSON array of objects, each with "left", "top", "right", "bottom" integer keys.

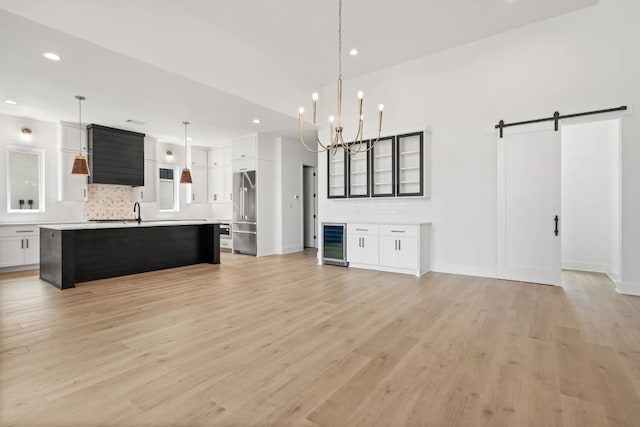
[{"left": 347, "top": 223, "right": 431, "bottom": 276}]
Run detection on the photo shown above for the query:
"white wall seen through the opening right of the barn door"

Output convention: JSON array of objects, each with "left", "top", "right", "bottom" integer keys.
[{"left": 561, "top": 120, "right": 620, "bottom": 280}]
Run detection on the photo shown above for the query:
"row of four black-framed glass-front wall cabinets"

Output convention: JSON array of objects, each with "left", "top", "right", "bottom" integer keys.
[{"left": 327, "top": 132, "right": 429, "bottom": 199}]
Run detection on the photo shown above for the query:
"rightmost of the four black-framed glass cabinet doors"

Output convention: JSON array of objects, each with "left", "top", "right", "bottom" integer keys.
[{"left": 396, "top": 132, "right": 423, "bottom": 196}]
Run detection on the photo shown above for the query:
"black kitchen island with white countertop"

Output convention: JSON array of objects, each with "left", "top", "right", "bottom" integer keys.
[{"left": 40, "top": 220, "right": 220, "bottom": 289}]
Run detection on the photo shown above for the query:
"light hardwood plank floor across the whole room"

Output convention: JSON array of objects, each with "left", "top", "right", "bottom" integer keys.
[{"left": 0, "top": 251, "right": 640, "bottom": 427}]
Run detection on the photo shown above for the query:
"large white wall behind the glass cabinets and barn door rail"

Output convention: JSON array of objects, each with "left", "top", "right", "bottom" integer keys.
[{"left": 318, "top": 0, "right": 640, "bottom": 294}]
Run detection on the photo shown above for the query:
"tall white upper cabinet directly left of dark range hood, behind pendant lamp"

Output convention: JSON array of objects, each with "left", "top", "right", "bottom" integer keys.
[{"left": 58, "top": 122, "right": 87, "bottom": 202}]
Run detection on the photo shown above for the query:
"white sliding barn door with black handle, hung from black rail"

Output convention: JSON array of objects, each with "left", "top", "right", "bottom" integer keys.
[{"left": 497, "top": 123, "right": 561, "bottom": 285}]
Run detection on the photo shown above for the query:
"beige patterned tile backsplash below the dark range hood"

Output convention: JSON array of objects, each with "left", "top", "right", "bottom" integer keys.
[{"left": 84, "top": 184, "right": 134, "bottom": 220}]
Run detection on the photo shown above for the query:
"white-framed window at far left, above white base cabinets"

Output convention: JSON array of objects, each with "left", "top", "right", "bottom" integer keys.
[{"left": 7, "top": 147, "right": 44, "bottom": 213}]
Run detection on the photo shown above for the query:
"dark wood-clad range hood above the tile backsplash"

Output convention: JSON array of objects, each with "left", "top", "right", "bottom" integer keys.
[{"left": 87, "top": 124, "right": 144, "bottom": 187}]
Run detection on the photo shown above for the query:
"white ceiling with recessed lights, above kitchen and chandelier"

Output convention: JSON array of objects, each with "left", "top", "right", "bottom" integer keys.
[{"left": 0, "top": 0, "right": 597, "bottom": 145}]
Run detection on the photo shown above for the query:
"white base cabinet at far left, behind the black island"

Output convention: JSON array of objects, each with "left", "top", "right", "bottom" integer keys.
[{"left": 0, "top": 225, "right": 40, "bottom": 268}]
